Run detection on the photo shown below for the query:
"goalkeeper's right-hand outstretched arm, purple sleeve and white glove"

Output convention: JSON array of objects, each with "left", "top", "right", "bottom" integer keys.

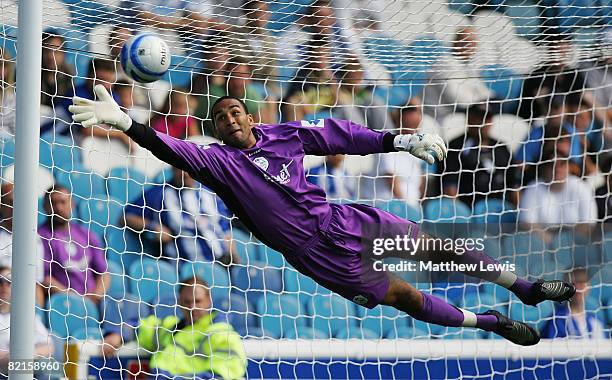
[{"left": 289, "top": 119, "right": 447, "bottom": 164}]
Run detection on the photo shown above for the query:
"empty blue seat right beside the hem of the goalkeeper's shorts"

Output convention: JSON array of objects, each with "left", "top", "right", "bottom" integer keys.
[{"left": 308, "top": 293, "right": 357, "bottom": 338}]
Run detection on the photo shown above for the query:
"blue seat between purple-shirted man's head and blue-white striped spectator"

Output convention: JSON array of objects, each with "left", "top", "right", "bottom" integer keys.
[{"left": 78, "top": 198, "right": 124, "bottom": 240}]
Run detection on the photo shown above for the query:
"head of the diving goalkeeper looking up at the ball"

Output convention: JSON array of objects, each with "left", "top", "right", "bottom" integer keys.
[{"left": 212, "top": 99, "right": 257, "bottom": 149}]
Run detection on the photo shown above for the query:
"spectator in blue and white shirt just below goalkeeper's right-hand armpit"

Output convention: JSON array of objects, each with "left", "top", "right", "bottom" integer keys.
[{"left": 306, "top": 154, "right": 355, "bottom": 201}]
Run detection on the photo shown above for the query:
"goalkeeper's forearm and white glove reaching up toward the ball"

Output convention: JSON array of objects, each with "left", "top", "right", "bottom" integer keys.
[{"left": 68, "top": 85, "right": 204, "bottom": 173}]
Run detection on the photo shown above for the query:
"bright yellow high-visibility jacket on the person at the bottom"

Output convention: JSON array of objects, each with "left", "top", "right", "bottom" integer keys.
[{"left": 138, "top": 313, "right": 247, "bottom": 379}]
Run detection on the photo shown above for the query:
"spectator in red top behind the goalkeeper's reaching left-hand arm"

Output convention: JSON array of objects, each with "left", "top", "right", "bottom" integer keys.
[{"left": 151, "top": 88, "right": 202, "bottom": 139}]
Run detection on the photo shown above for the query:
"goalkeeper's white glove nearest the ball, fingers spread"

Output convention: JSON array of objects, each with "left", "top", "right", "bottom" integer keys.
[{"left": 68, "top": 84, "right": 132, "bottom": 132}]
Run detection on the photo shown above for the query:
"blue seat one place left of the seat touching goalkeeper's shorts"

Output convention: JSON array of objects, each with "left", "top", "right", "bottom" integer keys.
[{"left": 256, "top": 293, "right": 307, "bottom": 339}]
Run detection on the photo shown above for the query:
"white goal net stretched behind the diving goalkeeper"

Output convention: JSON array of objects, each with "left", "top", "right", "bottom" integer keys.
[{"left": 0, "top": 0, "right": 612, "bottom": 379}]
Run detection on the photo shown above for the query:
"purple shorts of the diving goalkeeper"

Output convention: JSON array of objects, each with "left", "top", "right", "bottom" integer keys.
[{"left": 285, "top": 204, "right": 419, "bottom": 309}]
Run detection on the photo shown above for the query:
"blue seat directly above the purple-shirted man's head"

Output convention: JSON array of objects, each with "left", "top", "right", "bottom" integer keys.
[{"left": 54, "top": 164, "right": 106, "bottom": 203}]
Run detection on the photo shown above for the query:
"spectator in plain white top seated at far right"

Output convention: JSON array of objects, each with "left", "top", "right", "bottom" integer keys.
[{"left": 519, "top": 148, "right": 597, "bottom": 225}]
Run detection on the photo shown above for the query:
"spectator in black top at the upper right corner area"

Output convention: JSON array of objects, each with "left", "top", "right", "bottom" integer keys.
[{"left": 519, "top": 34, "right": 585, "bottom": 121}]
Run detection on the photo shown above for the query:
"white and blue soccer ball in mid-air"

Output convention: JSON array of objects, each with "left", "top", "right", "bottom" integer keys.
[{"left": 121, "top": 33, "right": 170, "bottom": 83}]
